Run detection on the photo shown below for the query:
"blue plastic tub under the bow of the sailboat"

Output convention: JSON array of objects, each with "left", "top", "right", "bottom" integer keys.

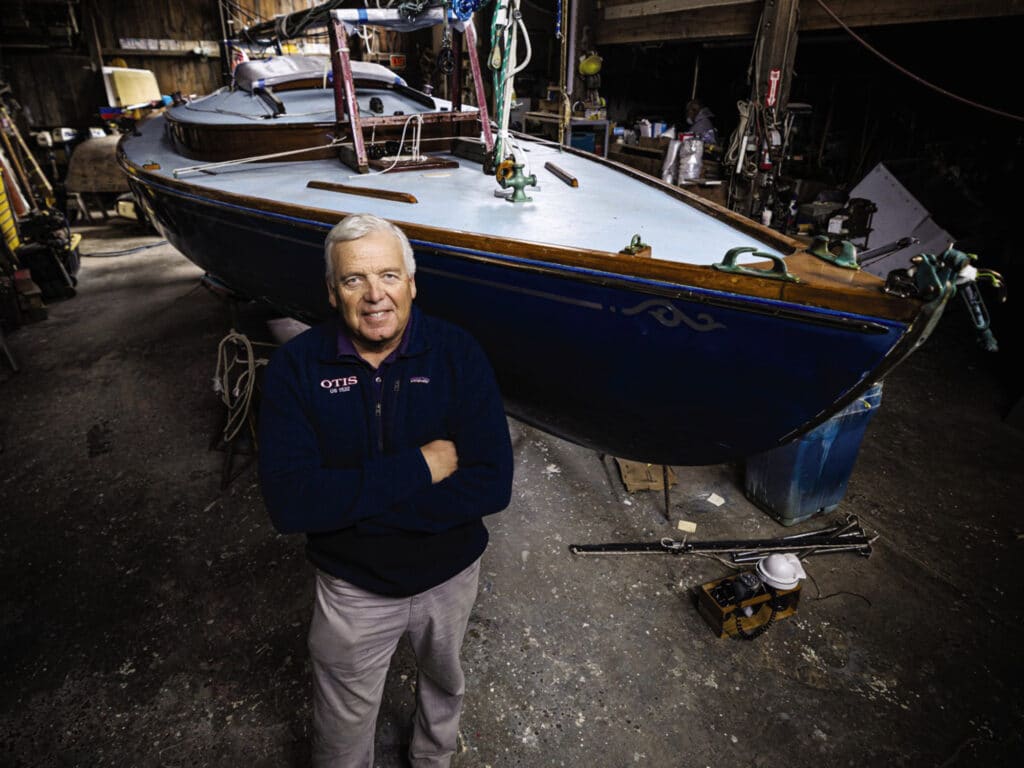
[{"left": 744, "top": 383, "right": 882, "bottom": 525}]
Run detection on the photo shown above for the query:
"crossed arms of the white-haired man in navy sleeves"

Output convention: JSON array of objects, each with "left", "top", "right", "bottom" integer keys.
[{"left": 259, "top": 342, "right": 512, "bottom": 532}]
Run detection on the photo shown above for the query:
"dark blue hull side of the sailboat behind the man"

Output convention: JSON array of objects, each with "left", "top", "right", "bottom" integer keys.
[{"left": 131, "top": 178, "right": 908, "bottom": 465}]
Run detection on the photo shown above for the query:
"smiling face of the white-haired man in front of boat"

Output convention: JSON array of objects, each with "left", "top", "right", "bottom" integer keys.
[{"left": 328, "top": 231, "right": 416, "bottom": 352}]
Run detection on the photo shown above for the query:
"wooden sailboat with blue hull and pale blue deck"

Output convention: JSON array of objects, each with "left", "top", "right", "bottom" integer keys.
[{"left": 119, "top": 0, "right": 978, "bottom": 465}]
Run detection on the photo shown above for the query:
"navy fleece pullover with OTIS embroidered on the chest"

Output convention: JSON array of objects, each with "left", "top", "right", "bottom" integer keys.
[{"left": 259, "top": 306, "right": 512, "bottom": 596}]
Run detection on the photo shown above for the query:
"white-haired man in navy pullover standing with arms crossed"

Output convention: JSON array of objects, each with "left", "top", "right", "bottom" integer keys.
[{"left": 259, "top": 214, "right": 512, "bottom": 768}]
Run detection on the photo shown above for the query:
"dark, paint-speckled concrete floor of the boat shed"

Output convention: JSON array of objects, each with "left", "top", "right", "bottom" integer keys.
[{"left": 6, "top": 218, "right": 1024, "bottom": 768}]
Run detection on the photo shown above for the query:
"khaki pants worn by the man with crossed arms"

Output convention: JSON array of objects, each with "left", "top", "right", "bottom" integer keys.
[{"left": 309, "top": 560, "right": 480, "bottom": 768}]
